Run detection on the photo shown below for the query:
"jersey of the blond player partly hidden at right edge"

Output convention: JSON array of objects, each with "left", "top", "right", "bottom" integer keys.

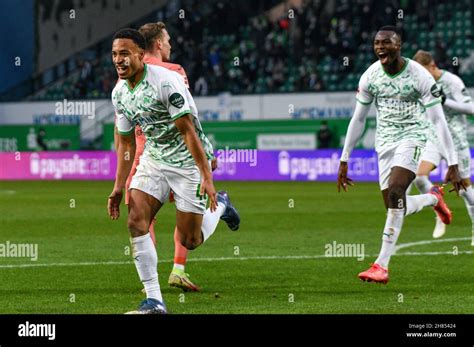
[{"left": 437, "top": 70, "right": 471, "bottom": 151}]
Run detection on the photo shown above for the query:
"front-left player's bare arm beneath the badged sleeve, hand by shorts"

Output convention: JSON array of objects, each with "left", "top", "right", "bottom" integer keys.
[{"left": 174, "top": 114, "right": 217, "bottom": 212}]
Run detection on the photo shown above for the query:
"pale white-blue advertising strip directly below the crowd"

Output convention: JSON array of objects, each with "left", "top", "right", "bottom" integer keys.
[{"left": 0, "top": 88, "right": 474, "bottom": 125}]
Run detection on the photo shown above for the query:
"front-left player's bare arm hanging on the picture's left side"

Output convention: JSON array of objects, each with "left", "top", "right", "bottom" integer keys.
[{"left": 107, "top": 131, "right": 136, "bottom": 220}]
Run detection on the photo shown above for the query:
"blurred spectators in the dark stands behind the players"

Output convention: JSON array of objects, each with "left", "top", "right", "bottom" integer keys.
[{"left": 21, "top": 0, "right": 474, "bottom": 100}]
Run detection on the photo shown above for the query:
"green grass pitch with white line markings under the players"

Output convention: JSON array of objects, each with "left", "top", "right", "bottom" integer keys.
[{"left": 0, "top": 182, "right": 474, "bottom": 314}]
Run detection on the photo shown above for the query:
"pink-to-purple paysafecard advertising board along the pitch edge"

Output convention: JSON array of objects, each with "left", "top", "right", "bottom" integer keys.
[{"left": 0, "top": 148, "right": 466, "bottom": 182}]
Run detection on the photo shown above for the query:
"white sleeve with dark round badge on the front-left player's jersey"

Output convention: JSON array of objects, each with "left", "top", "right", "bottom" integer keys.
[{"left": 161, "top": 72, "right": 191, "bottom": 120}]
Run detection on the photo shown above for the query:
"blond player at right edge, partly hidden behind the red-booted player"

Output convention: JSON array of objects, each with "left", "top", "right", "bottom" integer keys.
[{"left": 413, "top": 50, "right": 474, "bottom": 246}]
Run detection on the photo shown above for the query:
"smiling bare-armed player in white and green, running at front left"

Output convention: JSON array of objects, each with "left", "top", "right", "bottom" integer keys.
[{"left": 108, "top": 29, "right": 240, "bottom": 314}]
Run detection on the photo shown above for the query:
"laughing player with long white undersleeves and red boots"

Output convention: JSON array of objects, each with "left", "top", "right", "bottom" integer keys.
[{"left": 337, "top": 26, "right": 463, "bottom": 283}]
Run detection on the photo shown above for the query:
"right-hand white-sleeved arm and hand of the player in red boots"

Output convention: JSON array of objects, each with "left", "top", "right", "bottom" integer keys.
[{"left": 426, "top": 104, "right": 466, "bottom": 193}]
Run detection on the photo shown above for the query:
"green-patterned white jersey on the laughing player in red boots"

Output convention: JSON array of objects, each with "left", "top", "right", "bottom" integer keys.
[{"left": 356, "top": 58, "right": 441, "bottom": 152}]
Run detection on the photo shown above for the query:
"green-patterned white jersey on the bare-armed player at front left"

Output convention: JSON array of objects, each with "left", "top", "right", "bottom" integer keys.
[{"left": 112, "top": 64, "right": 214, "bottom": 167}]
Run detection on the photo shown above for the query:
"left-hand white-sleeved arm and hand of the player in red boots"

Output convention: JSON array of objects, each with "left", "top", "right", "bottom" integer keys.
[{"left": 337, "top": 102, "right": 370, "bottom": 192}]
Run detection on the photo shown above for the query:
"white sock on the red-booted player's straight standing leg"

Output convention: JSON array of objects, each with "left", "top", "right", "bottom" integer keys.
[{"left": 375, "top": 208, "right": 405, "bottom": 269}]
